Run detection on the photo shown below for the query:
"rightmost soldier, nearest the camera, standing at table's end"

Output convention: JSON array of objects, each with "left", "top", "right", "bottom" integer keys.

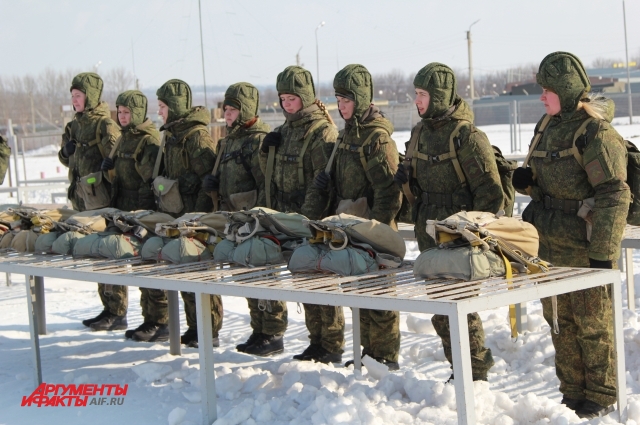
[{"left": 513, "top": 52, "right": 631, "bottom": 419}]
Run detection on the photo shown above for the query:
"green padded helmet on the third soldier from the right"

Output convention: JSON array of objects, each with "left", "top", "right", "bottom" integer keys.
[{"left": 333, "top": 64, "right": 373, "bottom": 117}]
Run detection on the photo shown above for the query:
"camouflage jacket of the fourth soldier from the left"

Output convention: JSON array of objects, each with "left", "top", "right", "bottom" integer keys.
[{"left": 217, "top": 118, "right": 271, "bottom": 210}]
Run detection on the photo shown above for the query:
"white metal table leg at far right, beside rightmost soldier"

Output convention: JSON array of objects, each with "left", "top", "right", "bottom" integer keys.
[{"left": 611, "top": 276, "right": 629, "bottom": 423}]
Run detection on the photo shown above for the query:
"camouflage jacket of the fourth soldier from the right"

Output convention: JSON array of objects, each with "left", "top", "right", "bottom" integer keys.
[{"left": 260, "top": 104, "right": 338, "bottom": 220}]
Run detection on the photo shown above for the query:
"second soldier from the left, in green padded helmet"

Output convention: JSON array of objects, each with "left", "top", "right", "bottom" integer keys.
[{"left": 101, "top": 90, "right": 169, "bottom": 341}]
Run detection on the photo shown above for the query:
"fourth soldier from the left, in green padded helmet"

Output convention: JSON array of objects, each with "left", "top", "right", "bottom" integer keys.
[{"left": 202, "top": 83, "right": 287, "bottom": 356}]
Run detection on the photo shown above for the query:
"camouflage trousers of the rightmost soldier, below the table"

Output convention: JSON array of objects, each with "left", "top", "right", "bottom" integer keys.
[{"left": 541, "top": 285, "right": 616, "bottom": 406}]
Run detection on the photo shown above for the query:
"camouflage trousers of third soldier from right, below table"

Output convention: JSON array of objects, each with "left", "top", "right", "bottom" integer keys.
[{"left": 360, "top": 308, "right": 400, "bottom": 362}]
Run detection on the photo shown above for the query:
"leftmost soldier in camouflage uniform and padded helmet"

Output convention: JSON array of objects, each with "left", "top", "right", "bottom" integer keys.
[{"left": 58, "top": 72, "right": 128, "bottom": 331}]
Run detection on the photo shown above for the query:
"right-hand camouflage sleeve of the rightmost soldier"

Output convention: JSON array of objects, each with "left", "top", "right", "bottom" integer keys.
[{"left": 583, "top": 121, "right": 631, "bottom": 261}]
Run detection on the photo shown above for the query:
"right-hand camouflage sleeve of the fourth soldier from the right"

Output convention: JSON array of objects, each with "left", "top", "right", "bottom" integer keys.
[{"left": 301, "top": 125, "right": 338, "bottom": 220}]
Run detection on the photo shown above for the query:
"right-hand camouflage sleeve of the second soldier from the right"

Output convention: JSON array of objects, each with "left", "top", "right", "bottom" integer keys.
[{"left": 458, "top": 127, "right": 504, "bottom": 213}]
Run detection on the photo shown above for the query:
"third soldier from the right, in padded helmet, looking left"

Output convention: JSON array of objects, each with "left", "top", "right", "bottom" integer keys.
[{"left": 314, "top": 65, "right": 402, "bottom": 370}]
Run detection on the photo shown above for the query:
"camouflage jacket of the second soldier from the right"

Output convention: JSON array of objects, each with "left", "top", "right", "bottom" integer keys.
[{"left": 410, "top": 99, "right": 504, "bottom": 250}]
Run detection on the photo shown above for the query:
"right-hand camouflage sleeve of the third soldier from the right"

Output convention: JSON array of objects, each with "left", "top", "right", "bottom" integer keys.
[{"left": 367, "top": 133, "right": 402, "bottom": 224}]
